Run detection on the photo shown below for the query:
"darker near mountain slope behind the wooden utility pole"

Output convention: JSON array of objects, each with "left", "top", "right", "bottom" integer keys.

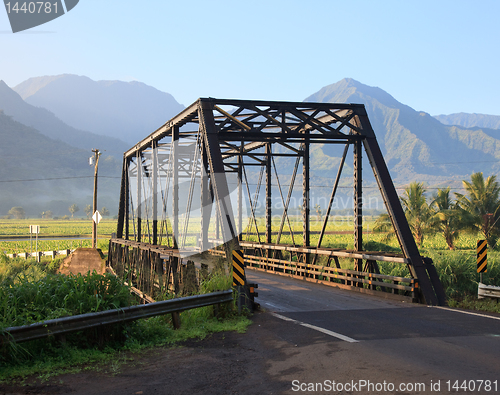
[{"left": 0, "top": 110, "right": 121, "bottom": 216}]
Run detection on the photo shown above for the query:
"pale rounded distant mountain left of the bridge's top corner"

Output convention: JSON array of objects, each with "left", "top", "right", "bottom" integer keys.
[{"left": 14, "top": 74, "right": 184, "bottom": 145}]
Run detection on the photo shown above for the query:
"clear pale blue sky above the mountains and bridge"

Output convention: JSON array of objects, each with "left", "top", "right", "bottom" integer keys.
[{"left": 0, "top": 0, "right": 500, "bottom": 115}]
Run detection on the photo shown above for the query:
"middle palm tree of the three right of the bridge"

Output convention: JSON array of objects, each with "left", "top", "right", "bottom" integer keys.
[{"left": 430, "top": 187, "right": 462, "bottom": 250}]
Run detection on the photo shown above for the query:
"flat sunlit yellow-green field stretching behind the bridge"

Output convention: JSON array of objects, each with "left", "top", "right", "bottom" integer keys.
[{"left": 0, "top": 216, "right": 486, "bottom": 254}]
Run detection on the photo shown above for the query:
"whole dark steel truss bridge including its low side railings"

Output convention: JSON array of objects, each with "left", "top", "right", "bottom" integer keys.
[{"left": 108, "top": 98, "right": 446, "bottom": 305}]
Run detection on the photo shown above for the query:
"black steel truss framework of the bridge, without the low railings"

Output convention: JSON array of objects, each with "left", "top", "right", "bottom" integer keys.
[{"left": 117, "top": 98, "right": 446, "bottom": 305}]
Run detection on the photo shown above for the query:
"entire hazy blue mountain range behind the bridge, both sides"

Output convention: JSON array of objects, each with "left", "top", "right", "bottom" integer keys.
[{"left": 0, "top": 74, "right": 500, "bottom": 217}]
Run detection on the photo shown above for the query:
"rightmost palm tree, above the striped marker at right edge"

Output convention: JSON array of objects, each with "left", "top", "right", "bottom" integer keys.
[{"left": 455, "top": 172, "right": 500, "bottom": 246}]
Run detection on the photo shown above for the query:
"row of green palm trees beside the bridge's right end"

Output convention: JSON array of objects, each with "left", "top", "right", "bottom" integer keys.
[{"left": 374, "top": 172, "right": 500, "bottom": 250}]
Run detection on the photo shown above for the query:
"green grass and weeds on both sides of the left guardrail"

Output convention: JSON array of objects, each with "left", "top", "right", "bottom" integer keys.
[{"left": 0, "top": 255, "right": 251, "bottom": 383}]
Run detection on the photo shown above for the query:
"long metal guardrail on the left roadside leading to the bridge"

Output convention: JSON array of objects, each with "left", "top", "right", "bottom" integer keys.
[{"left": 0, "top": 290, "right": 233, "bottom": 344}]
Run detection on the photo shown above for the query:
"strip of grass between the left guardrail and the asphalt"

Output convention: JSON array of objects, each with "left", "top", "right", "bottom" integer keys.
[{"left": 0, "top": 308, "right": 251, "bottom": 383}]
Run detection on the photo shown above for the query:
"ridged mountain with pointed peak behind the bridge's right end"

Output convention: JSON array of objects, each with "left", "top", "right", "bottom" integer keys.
[{"left": 305, "top": 79, "right": 500, "bottom": 184}]
